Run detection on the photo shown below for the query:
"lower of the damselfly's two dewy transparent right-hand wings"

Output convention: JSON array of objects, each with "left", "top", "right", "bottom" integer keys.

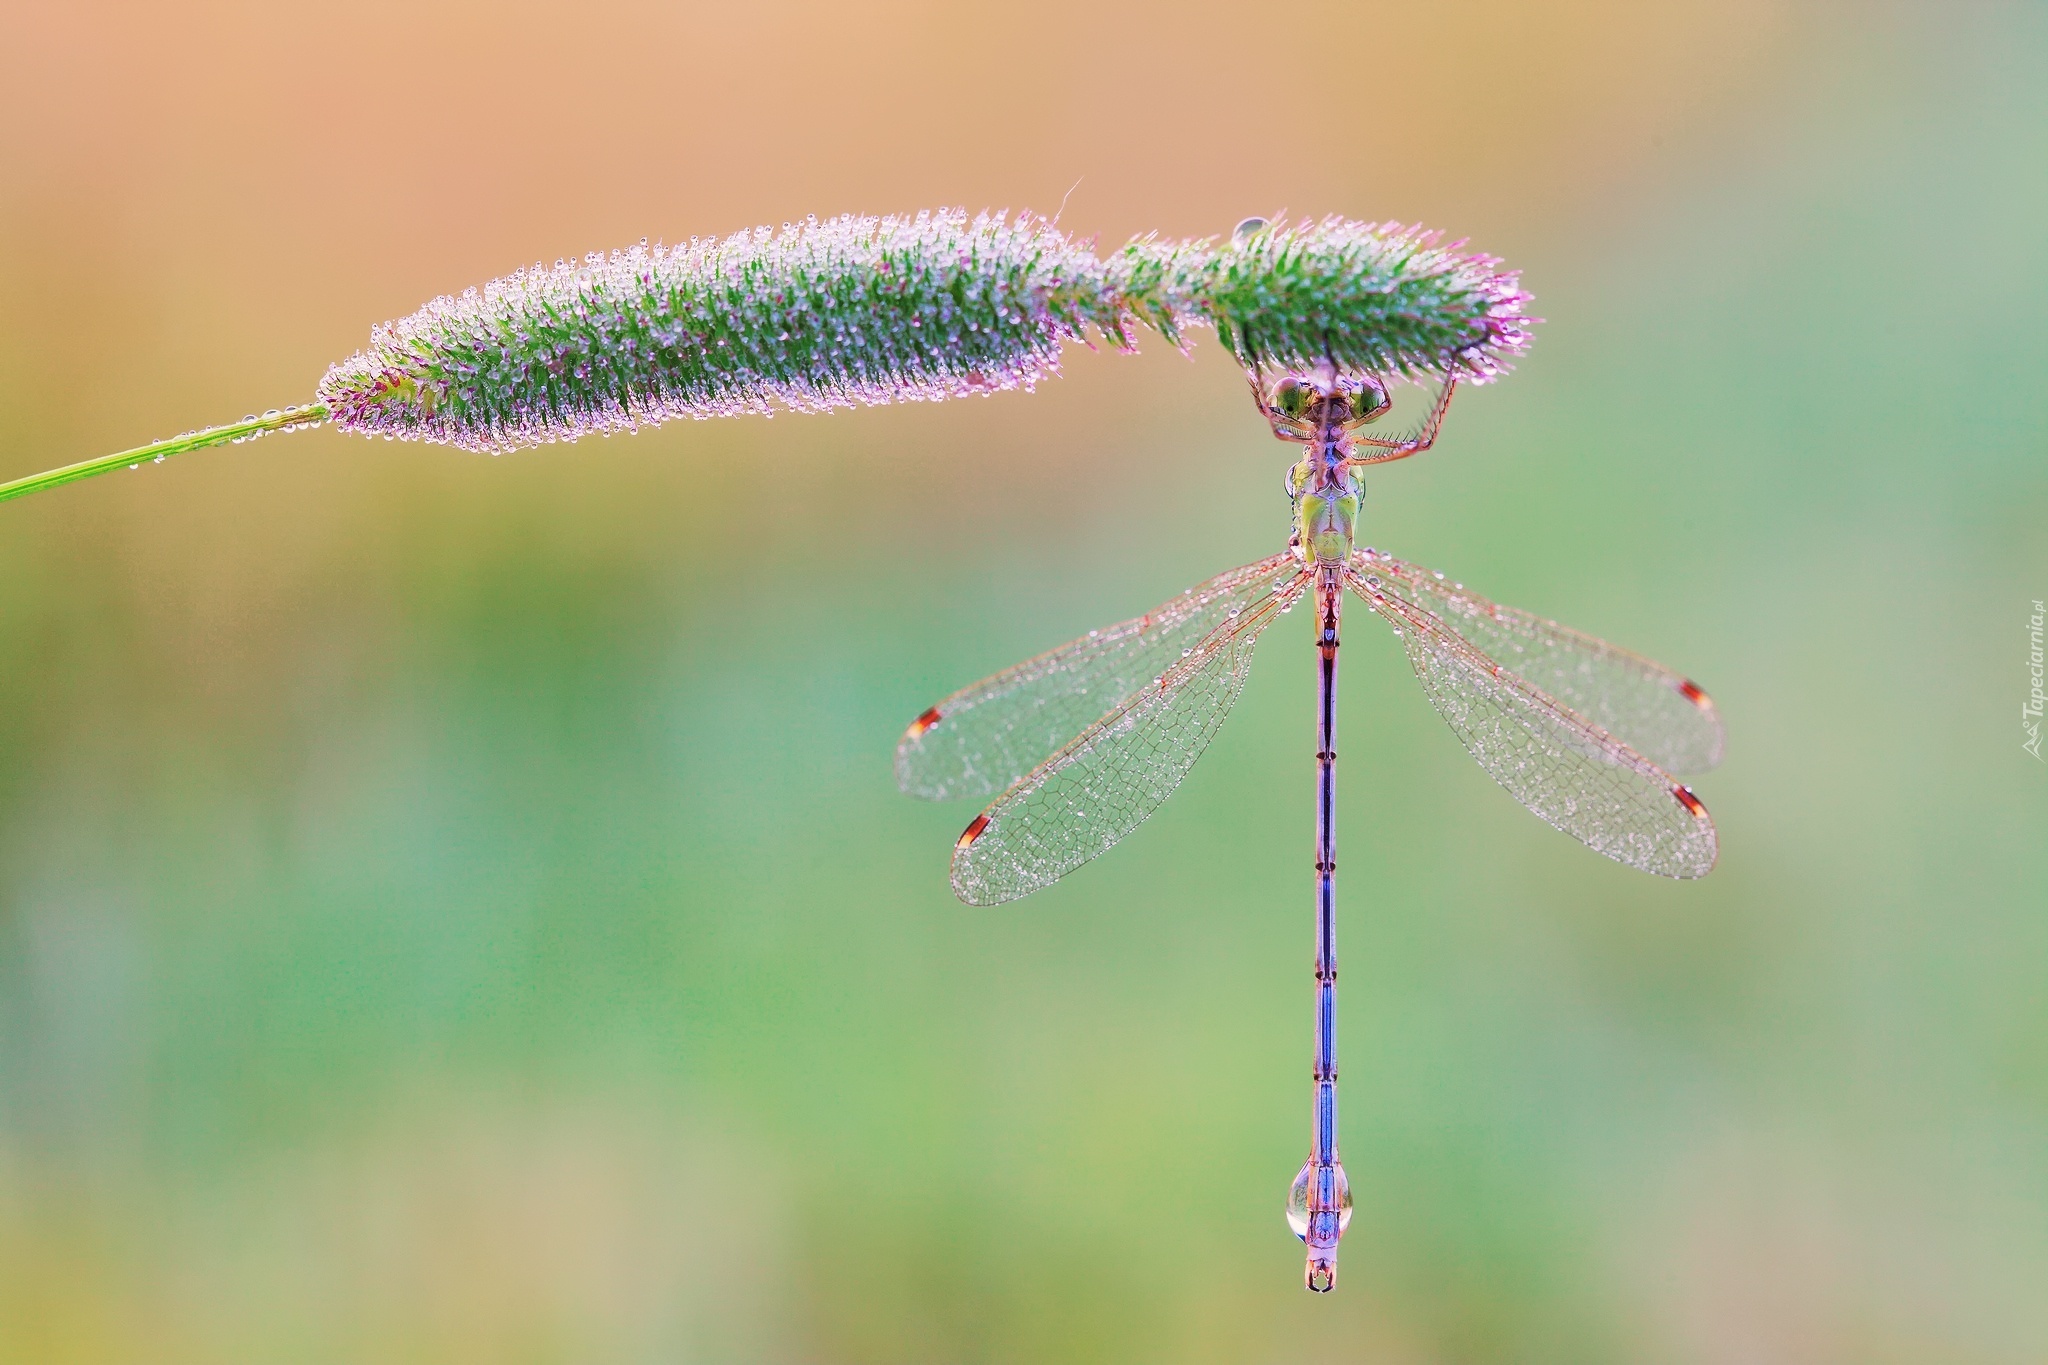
[{"left": 1346, "top": 571, "right": 1718, "bottom": 878}]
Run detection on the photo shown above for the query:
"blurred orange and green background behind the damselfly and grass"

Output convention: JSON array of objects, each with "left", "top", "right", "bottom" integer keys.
[{"left": 0, "top": 0, "right": 2048, "bottom": 1365}]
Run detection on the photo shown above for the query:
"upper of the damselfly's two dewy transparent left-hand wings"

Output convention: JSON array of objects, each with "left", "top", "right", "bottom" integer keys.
[{"left": 897, "top": 555, "right": 1300, "bottom": 800}]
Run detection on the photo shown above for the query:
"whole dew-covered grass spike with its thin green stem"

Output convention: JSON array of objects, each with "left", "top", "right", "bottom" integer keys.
[{"left": 0, "top": 209, "right": 1536, "bottom": 501}]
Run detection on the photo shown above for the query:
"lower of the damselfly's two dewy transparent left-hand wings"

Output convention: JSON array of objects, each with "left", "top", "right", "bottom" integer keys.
[{"left": 952, "top": 561, "right": 1309, "bottom": 905}]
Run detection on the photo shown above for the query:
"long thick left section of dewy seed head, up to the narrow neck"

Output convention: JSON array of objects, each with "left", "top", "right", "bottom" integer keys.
[{"left": 319, "top": 209, "right": 1122, "bottom": 452}]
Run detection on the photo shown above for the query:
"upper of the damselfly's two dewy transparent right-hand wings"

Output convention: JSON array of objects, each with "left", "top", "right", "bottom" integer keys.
[{"left": 1352, "top": 551, "right": 1722, "bottom": 774}]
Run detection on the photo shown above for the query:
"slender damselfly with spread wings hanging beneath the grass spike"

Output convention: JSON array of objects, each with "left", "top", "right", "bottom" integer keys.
[{"left": 895, "top": 364, "right": 1722, "bottom": 1293}]
